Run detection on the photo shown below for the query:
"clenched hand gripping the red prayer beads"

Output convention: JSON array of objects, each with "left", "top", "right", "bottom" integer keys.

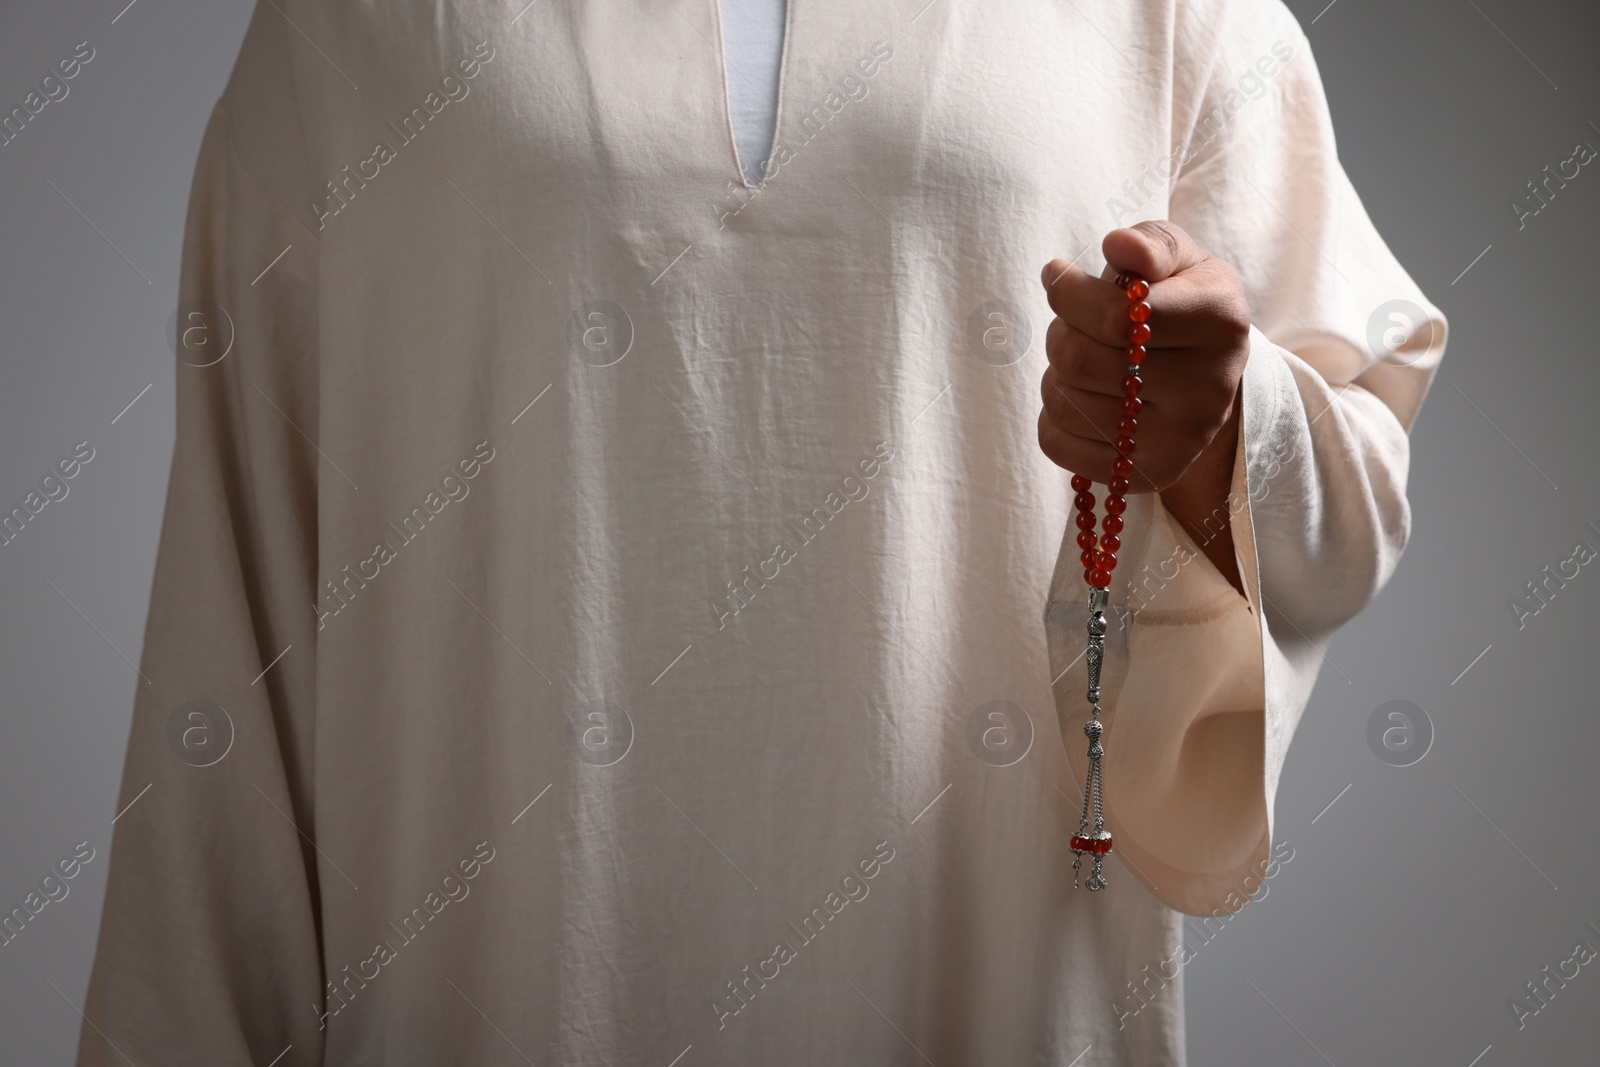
[{"left": 1038, "top": 222, "right": 1250, "bottom": 495}]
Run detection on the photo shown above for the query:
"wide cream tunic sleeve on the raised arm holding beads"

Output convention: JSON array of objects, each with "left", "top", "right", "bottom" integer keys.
[{"left": 1046, "top": 0, "right": 1445, "bottom": 913}]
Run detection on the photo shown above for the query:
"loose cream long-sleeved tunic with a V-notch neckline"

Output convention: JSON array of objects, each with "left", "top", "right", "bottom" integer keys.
[{"left": 80, "top": 0, "right": 1443, "bottom": 1067}]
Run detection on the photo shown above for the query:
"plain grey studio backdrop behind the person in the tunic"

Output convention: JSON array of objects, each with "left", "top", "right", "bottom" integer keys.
[{"left": 0, "top": 0, "right": 1600, "bottom": 1067}]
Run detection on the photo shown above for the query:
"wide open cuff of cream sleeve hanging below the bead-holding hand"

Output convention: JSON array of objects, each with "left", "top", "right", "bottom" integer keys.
[{"left": 1046, "top": 333, "right": 1286, "bottom": 915}]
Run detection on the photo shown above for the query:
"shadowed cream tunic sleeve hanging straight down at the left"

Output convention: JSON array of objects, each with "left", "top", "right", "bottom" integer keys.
[{"left": 77, "top": 6, "right": 328, "bottom": 1067}]
